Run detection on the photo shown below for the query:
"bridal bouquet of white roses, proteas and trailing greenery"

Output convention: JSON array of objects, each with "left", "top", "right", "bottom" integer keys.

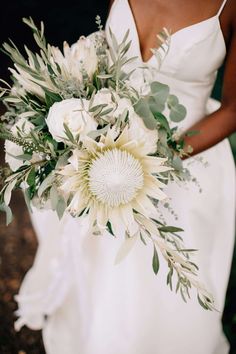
[{"left": 0, "top": 18, "right": 213, "bottom": 309}]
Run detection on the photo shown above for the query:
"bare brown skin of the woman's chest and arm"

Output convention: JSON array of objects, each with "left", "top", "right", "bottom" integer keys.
[{"left": 108, "top": 0, "right": 236, "bottom": 155}]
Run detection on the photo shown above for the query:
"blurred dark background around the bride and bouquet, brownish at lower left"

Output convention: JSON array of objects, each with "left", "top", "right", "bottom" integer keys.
[{"left": 0, "top": 0, "right": 236, "bottom": 354}]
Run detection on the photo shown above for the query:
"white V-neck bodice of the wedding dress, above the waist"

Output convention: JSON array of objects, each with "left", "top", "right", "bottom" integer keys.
[{"left": 106, "top": 0, "right": 227, "bottom": 128}]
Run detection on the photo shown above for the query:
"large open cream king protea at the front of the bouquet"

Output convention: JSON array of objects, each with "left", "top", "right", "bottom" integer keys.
[{"left": 60, "top": 127, "right": 170, "bottom": 236}]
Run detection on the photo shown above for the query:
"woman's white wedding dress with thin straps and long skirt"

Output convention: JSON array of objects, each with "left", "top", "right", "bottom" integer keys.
[{"left": 16, "top": 0, "right": 235, "bottom": 354}]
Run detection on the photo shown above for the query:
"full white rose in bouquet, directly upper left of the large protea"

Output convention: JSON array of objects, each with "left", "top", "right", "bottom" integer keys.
[{"left": 46, "top": 98, "right": 97, "bottom": 142}]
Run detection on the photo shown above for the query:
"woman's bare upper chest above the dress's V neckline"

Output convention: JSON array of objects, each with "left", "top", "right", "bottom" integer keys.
[{"left": 128, "top": 0, "right": 228, "bottom": 62}]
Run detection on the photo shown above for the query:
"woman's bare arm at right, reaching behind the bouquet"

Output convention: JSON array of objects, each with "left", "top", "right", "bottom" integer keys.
[{"left": 184, "top": 7, "right": 236, "bottom": 155}]
